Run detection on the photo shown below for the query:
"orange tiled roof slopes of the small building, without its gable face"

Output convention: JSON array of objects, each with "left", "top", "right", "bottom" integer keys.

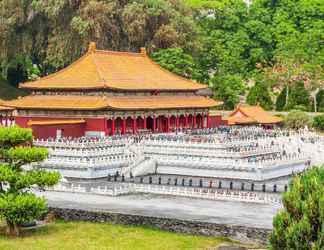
[{"left": 229, "top": 105, "right": 282, "bottom": 124}]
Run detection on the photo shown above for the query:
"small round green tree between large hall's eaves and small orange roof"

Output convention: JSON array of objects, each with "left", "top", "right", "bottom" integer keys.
[{"left": 211, "top": 75, "right": 245, "bottom": 110}]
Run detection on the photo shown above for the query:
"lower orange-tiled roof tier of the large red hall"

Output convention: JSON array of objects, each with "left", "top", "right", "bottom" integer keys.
[{"left": 6, "top": 95, "right": 222, "bottom": 110}]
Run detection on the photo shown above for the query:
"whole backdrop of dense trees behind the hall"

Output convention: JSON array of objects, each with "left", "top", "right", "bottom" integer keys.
[{"left": 0, "top": 0, "right": 324, "bottom": 110}]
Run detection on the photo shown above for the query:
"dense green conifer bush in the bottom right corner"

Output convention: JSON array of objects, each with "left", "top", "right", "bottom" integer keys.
[{"left": 269, "top": 166, "right": 324, "bottom": 250}]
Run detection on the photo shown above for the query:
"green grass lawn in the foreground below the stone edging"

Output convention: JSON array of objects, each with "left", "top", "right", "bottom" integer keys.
[{"left": 0, "top": 221, "right": 238, "bottom": 250}]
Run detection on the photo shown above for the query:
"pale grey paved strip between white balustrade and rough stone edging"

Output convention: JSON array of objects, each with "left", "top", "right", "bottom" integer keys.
[{"left": 38, "top": 192, "right": 280, "bottom": 229}]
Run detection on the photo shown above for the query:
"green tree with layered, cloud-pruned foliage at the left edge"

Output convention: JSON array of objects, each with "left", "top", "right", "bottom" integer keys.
[{"left": 0, "top": 127, "right": 60, "bottom": 235}]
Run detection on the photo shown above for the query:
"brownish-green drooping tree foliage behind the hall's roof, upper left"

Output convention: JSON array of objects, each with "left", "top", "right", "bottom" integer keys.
[{"left": 0, "top": 0, "right": 199, "bottom": 74}]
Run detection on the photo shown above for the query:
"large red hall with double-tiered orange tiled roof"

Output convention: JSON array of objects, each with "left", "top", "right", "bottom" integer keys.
[{"left": 6, "top": 43, "right": 222, "bottom": 138}]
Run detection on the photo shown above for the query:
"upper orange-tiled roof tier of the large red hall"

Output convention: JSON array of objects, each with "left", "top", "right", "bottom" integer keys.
[{"left": 20, "top": 44, "right": 207, "bottom": 91}]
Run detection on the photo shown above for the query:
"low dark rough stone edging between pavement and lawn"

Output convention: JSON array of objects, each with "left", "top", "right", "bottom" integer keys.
[{"left": 49, "top": 207, "right": 271, "bottom": 245}]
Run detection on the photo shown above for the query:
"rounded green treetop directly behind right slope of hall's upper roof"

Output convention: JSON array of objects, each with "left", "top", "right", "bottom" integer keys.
[{"left": 152, "top": 48, "right": 201, "bottom": 80}]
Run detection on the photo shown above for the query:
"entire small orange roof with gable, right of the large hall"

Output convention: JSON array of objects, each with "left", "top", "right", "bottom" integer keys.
[{"left": 227, "top": 105, "right": 282, "bottom": 124}]
